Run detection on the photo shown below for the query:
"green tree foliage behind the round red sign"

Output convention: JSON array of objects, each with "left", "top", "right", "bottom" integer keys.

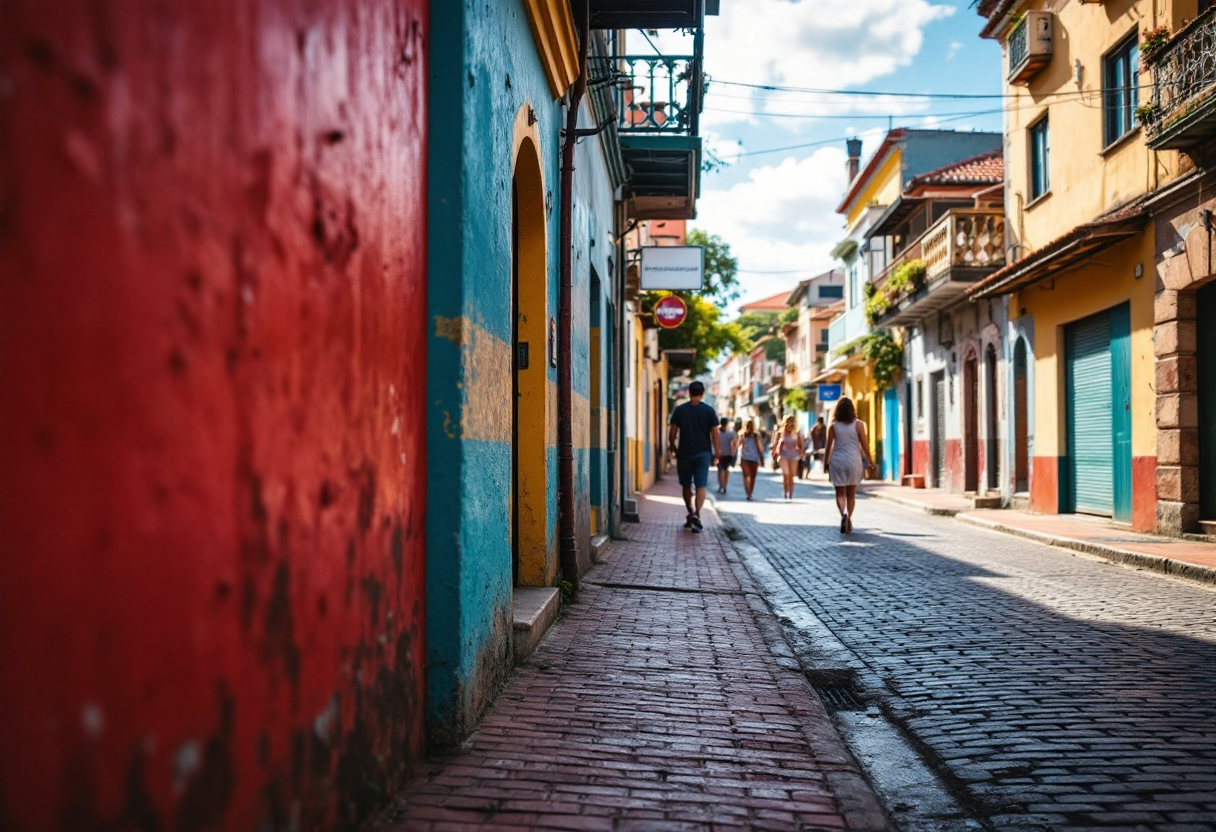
[{"left": 640, "top": 223, "right": 751, "bottom": 376}]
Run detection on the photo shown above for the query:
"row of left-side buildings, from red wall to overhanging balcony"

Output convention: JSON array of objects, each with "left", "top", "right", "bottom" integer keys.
[{"left": 0, "top": 0, "right": 717, "bottom": 832}]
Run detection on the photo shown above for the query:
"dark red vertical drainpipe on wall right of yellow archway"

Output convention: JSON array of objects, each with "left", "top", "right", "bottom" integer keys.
[{"left": 557, "top": 0, "right": 591, "bottom": 592}]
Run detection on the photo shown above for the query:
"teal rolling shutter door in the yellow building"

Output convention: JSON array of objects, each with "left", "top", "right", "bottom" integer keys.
[{"left": 1064, "top": 313, "right": 1115, "bottom": 516}]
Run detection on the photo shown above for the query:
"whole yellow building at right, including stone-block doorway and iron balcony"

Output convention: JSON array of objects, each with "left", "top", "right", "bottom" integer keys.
[{"left": 970, "top": 0, "right": 1216, "bottom": 534}]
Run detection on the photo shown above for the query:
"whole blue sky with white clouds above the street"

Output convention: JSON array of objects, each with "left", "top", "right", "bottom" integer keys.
[{"left": 656, "top": 0, "right": 1003, "bottom": 311}]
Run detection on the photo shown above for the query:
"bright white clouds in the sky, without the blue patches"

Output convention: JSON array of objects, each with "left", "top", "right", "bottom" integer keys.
[{"left": 676, "top": 0, "right": 955, "bottom": 308}]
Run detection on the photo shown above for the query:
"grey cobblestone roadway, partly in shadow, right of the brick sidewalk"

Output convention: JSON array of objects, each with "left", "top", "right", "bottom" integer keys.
[{"left": 717, "top": 473, "right": 1216, "bottom": 832}]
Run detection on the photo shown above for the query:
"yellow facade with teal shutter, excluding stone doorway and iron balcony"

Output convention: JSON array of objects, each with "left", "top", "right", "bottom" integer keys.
[{"left": 972, "top": 0, "right": 1195, "bottom": 530}]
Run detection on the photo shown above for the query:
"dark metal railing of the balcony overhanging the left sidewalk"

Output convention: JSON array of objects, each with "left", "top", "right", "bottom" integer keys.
[{"left": 617, "top": 55, "right": 704, "bottom": 136}]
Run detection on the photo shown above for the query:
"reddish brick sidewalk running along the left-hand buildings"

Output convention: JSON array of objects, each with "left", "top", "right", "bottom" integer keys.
[{"left": 381, "top": 482, "right": 889, "bottom": 832}]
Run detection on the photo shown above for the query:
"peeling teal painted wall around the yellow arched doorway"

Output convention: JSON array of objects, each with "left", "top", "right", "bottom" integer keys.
[{"left": 426, "top": 0, "right": 561, "bottom": 743}]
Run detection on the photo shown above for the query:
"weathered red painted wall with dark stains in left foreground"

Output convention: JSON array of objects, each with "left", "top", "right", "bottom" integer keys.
[{"left": 0, "top": 0, "right": 427, "bottom": 832}]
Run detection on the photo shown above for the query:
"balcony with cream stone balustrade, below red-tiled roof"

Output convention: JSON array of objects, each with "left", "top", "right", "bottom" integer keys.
[{"left": 874, "top": 208, "right": 1004, "bottom": 326}]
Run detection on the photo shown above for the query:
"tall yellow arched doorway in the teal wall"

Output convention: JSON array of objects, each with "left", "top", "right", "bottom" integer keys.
[{"left": 511, "top": 136, "right": 556, "bottom": 586}]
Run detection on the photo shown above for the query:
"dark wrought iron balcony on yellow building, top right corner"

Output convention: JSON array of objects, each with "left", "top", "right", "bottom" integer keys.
[{"left": 1137, "top": 7, "right": 1216, "bottom": 150}]
